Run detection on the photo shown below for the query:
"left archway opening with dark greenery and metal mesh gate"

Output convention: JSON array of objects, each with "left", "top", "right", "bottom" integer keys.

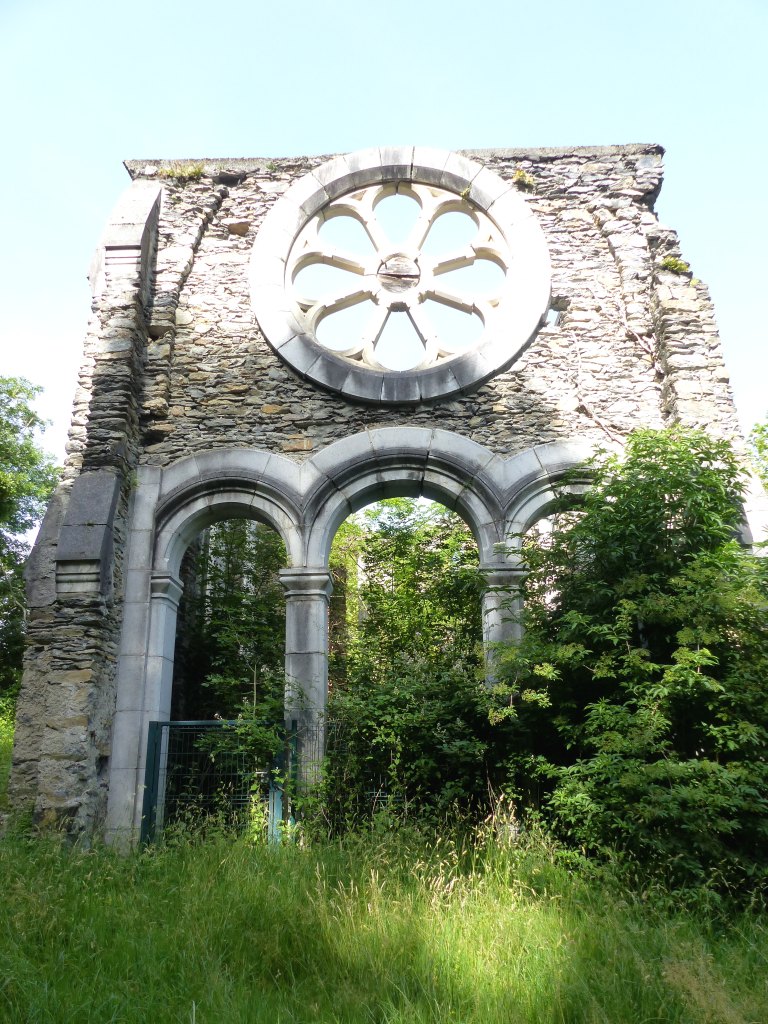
[{"left": 142, "top": 518, "right": 290, "bottom": 840}]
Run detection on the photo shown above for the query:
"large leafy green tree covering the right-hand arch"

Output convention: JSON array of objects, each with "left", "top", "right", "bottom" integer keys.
[{"left": 495, "top": 429, "right": 768, "bottom": 885}]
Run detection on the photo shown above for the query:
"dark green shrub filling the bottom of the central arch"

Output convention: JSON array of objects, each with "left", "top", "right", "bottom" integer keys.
[{"left": 326, "top": 654, "right": 510, "bottom": 824}]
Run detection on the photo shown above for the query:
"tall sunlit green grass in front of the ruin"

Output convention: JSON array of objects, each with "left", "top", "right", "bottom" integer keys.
[{"left": 0, "top": 829, "right": 768, "bottom": 1024}]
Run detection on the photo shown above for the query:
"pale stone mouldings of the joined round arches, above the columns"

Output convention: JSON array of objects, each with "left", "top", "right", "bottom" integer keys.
[{"left": 153, "top": 436, "right": 591, "bottom": 574}]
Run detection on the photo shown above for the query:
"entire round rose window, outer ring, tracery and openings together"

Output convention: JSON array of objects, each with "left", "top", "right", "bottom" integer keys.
[{"left": 251, "top": 148, "right": 550, "bottom": 403}]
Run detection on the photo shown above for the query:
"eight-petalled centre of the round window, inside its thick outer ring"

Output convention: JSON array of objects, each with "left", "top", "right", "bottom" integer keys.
[{"left": 288, "top": 183, "right": 510, "bottom": 371}]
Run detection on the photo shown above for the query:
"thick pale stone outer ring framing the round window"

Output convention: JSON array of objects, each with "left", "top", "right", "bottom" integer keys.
[{"left": 250, "top": 146, "right": 551, "bottom": 406}]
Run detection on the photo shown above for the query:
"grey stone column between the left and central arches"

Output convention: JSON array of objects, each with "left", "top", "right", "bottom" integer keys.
[{"left": 280, "top": 568, "right": 333, "bottom": 785}]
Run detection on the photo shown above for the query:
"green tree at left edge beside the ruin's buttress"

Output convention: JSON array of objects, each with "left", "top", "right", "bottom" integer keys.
[{"left": 0, "top": 377, "right": 57, "bottom": 695}]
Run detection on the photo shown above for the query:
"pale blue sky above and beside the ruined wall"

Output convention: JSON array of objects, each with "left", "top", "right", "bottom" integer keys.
[{"left": 0, "top": 0, "right": 768, "bottom": 456}]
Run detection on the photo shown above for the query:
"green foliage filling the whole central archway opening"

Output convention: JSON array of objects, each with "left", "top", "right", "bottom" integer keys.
[{"left": 327, "top": 498, "right": 503, "bottom": 816}]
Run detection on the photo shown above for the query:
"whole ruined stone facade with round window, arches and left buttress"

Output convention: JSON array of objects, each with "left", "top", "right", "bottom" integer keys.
[{"left": 10, "top": 144, "right": 765, "bottom": 844}]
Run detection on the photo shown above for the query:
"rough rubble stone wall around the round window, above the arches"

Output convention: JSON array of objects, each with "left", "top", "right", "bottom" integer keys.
[{"left": 129, "top": 145, "right": 738, "bottom": 465}]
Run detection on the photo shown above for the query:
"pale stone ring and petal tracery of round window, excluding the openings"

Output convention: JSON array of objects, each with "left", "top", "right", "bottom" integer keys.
[{"left": 250, "top": 146, "right": 551, "bottom": 404}]
